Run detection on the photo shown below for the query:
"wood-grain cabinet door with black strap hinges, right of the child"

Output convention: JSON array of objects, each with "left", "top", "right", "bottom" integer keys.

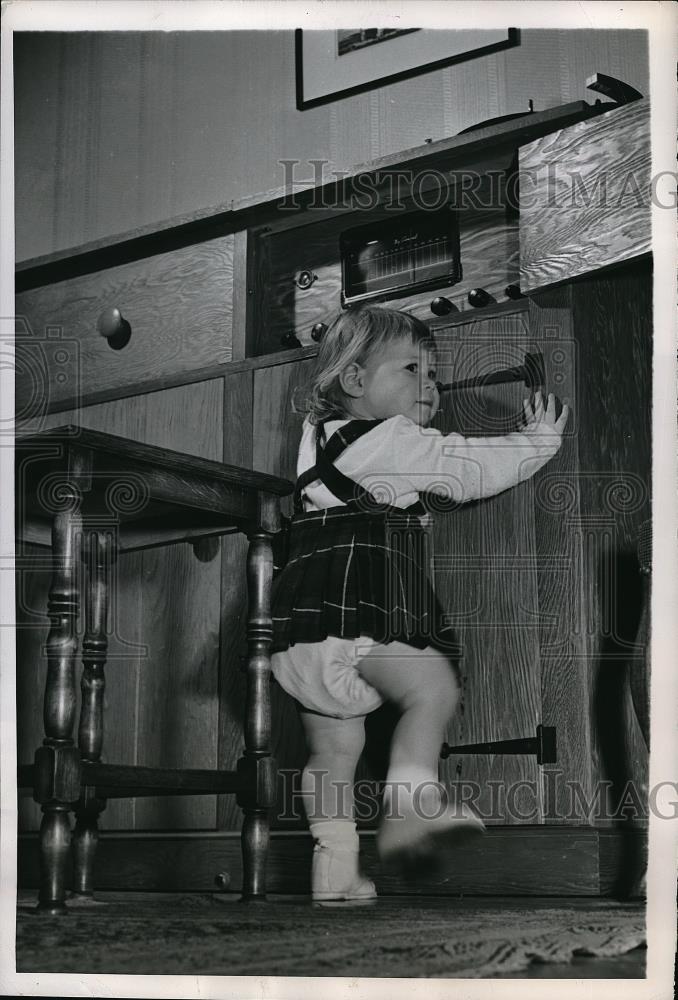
[{"left": 434, "top": 311, "right": 542, "bottom": 823}]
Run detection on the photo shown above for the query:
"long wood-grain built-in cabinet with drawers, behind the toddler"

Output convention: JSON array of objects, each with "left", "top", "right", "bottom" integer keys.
[{"left": 17, "top": 102, "right": 652, "bottom": 884}]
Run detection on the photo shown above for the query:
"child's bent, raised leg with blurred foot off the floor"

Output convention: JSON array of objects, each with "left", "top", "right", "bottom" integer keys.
[{"left": 357, "top": 642, "right": 483, "bottom": 860}]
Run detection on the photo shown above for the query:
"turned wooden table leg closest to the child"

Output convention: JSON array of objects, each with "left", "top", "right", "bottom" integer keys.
[{"left": 237, "top": 531, "right": 275, "bottom": 900}]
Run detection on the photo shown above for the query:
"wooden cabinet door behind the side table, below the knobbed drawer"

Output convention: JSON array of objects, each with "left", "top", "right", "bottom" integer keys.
[{"left": 17, "top": 379, "right": 223, "bottom": 829}]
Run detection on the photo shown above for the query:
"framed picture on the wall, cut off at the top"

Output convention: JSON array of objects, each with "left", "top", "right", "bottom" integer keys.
[{"left": 295, "top": 28, "right": 520, "bottom": 111}]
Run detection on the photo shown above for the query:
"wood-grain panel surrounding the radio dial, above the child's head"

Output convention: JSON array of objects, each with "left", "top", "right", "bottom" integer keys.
[{"left": 255, "top": 201, "right": 519, "bottom": 353}]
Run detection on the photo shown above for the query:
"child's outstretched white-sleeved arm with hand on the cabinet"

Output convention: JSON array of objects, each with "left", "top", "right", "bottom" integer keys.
[{"left": 353, "top": 393, "right": 569, "bottom": 502}]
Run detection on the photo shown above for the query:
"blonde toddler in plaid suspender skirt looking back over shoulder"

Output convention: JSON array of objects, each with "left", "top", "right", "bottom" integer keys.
[{"left": 272, "top": 307, "right": 568, "bottom": 900}]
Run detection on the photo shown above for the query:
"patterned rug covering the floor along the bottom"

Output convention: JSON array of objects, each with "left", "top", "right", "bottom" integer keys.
[{"left": 17, "top": 896, "right": 645, "bottom": 978}]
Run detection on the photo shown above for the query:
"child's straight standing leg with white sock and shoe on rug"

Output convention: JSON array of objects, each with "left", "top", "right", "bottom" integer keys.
[{"left": 300, "top": 710, "right": 376, "bottom": 900}]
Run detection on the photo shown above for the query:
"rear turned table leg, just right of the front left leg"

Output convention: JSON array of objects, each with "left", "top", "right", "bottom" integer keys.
[{"left": 73, "top": 529, "right": 115, "bottom": 896}]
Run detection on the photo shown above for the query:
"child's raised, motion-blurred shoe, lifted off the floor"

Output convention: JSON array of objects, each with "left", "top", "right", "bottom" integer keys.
[{"left": 377, "top": 803, "right": 485, "bottom": 875}]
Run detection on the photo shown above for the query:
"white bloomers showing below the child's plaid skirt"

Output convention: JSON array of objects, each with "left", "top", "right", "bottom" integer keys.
[{"left": 271, "top": 636, "right": 384, "bottom": 719}]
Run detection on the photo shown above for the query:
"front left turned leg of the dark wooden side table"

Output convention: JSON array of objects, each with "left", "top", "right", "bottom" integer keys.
[{"left": 34, "top": 492, "right": 81, "bottom": 913}]
